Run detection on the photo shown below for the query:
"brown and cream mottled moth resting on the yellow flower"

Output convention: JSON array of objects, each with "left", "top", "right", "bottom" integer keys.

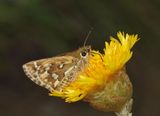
[{"left": 23, "top": 46, "right": 91, "bottom": 91}]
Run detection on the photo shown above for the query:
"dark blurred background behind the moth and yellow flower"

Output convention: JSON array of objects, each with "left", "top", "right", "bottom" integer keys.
[{"left": 0, "top": 0, "right": 160, "bottom": 116}]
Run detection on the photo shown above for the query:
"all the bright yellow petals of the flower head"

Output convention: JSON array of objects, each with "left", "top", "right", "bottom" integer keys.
[{"left": 50, "top": 32, "right": 138, "bottom": 102}]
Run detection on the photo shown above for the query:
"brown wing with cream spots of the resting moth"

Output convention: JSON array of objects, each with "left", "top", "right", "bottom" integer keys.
[{"left": 23, "top": 56, "right": 77, "bottom": 91}]
